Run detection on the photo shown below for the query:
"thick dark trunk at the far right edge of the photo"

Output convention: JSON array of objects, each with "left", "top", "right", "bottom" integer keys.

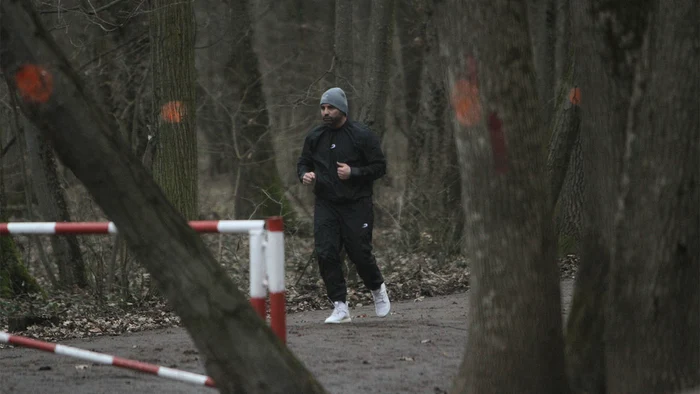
[{"left": 591, "top": 0, "right": 700, "bottom": 393}]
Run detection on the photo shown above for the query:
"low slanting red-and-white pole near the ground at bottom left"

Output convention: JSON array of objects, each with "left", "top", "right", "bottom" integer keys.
[{"left": 0, "top": 331, "right": 216, "bottom": 387}]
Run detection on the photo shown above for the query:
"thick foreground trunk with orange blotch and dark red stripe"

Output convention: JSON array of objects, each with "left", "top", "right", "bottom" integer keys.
[{"left": 448, "top": 0, "right": 568, "bottom": 394}]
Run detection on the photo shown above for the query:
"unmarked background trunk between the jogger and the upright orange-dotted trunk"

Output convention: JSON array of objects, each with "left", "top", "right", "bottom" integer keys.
[{"left": 226, "top": 0, "right": 291, "bottom": 219}]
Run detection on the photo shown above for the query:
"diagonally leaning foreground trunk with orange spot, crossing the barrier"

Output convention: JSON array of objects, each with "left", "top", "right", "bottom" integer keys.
[{"left": 0, "top": 0, "right": 323, "bottom": 393}]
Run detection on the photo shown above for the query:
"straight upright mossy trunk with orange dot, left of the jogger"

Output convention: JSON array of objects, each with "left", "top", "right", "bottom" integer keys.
[{"left": 149, "top": 0, "right": 199, "bottom": 220}]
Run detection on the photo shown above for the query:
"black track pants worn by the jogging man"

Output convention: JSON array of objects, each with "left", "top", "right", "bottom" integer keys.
[{"left": 314, "top": 197, "right": 384, "bottom": 302}]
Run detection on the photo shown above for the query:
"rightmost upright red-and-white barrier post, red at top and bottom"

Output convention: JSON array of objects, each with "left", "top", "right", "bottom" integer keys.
[{"left": 265, "top": 216, "right": 287, "bottom": 343}]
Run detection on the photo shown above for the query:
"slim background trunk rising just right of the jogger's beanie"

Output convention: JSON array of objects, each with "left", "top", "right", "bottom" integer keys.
[{"left": 355, "top": 0, "right": 396, "bottom": 139}]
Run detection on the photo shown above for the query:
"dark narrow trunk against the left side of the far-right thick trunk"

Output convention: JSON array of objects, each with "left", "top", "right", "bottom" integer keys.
[{"left": 566, "top": 2, "right": 628, "bottom": 394}]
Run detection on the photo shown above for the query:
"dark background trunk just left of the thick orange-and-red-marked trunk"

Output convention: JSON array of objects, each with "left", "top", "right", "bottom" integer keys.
[{"left": 400, "top": 8, "right": 464, "bottom": 258}]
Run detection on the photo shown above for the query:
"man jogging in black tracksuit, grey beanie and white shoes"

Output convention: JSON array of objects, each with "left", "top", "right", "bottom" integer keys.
[{"left": 297, "top": 88, "right": 391, "bottom": 323}]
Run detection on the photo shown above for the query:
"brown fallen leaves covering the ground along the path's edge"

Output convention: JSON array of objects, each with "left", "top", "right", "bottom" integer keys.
[{"left": 0, "top": 232, "right": 578, "bottom": 348}]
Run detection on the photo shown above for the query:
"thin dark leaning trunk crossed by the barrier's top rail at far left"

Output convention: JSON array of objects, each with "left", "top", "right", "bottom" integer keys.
[{"left": 20, "top": 118, "right": 88, "bottom": 288}]
